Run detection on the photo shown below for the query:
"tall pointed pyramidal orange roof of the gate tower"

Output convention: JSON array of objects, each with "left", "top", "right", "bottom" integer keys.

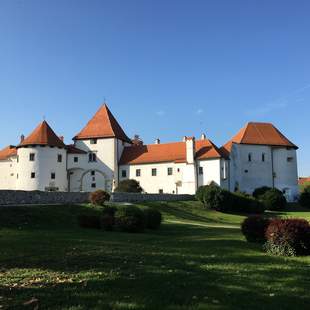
[{"left": 73, "top": 104, "right": 131, "bottom": 143}]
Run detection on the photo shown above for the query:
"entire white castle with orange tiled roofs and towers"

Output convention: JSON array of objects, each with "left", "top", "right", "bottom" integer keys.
[{"left": 0, "top": 104, "right": 298, "bottom": 201}]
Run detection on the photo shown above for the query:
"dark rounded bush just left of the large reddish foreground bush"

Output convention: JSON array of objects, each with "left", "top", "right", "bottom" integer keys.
[{"left": 241, "top": 215, "right": 270, "bottom": 243}]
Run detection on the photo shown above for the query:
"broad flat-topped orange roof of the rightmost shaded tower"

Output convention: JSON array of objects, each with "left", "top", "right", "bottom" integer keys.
[{"left": 221, "top": 123, "right": 298, "bottom": 154}]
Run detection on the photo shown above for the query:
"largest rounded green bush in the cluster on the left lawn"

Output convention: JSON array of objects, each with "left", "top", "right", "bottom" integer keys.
[{"left": 114, "top": 206, "right": 146, "bottom": 232}]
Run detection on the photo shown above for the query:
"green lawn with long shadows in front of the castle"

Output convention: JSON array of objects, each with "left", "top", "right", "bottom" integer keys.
[{"left": 0, "top": 202, "right": 310, "bottom": 310}]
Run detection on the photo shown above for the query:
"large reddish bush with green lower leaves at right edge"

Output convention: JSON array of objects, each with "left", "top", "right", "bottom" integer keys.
[{"left": 265, "top": 219, "right": 310, "bottom": 256}]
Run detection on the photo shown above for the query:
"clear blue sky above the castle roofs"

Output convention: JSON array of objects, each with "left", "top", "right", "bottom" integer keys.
[{"left": 0, "top": 0, "right": 310, "bottom": 175}]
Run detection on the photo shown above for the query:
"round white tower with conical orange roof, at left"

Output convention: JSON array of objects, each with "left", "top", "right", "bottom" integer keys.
[{"left": 16, "top": 121, "right": 68, "bottom": 191}]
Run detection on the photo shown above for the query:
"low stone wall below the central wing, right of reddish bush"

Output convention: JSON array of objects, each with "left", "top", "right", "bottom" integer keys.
[{"left": 111, "top": 193, "right": 194, "bottom": 202}]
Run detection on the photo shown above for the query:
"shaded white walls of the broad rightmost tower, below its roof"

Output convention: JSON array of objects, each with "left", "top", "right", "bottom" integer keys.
[{"left": 230, "top": 144, "right": 298, "bottom": 201}]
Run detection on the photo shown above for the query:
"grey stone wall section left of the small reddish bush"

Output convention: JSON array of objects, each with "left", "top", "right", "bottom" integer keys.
[{"left": 0, "top": 190, "right": 89, "bottom": 205}]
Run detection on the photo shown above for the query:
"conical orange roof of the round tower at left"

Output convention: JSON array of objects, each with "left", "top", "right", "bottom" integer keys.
[{"left": 17, "top": 121, "right": 65, "bottom": 148}]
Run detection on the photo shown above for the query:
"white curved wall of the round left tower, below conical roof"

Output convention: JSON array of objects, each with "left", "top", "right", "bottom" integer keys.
[{"left": 16, "top": 146, "right": 68, "bottom": 191}]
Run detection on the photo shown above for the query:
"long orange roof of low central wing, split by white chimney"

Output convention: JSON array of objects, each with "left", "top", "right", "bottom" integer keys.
[{"left": 119, "top": 139, "right": 222, "bottom": 165}]
